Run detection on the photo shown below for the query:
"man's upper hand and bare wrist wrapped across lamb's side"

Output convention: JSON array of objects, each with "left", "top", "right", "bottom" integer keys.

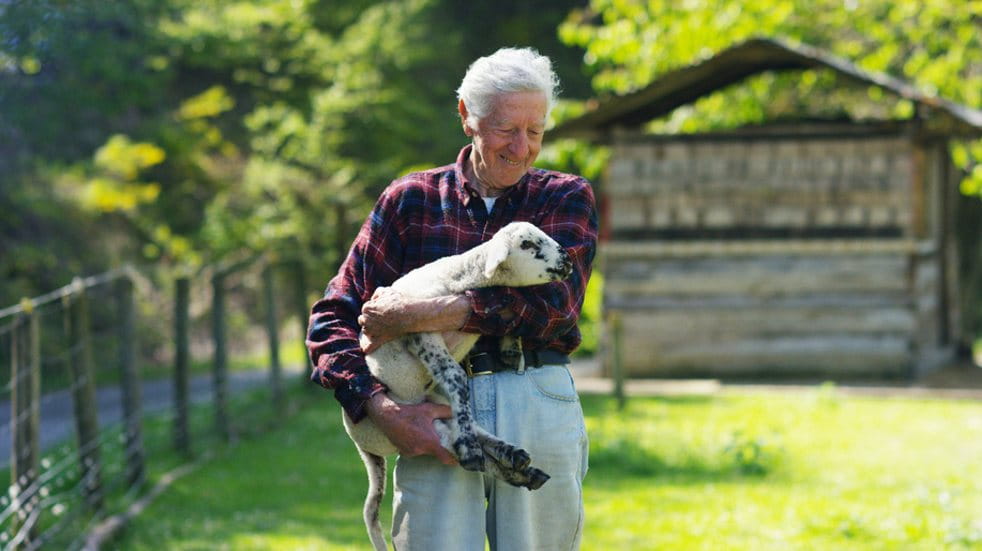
[{"left": 358, "top": 287, "right": 471, "bottom": 354}]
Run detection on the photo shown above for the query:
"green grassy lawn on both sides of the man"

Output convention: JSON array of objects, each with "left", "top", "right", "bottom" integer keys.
[{"left": 110, "top": 387, "right": 982, "bottom": 551}]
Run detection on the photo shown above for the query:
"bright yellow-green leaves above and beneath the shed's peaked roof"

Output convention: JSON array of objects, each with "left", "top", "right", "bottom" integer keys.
[{"left": 560, "top": 0, "right": 982, "bottom": 194}]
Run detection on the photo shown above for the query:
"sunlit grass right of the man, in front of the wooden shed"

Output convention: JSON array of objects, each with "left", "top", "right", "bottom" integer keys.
[{"left": 584, "top": 389, "right": 982, "bottom": 549}]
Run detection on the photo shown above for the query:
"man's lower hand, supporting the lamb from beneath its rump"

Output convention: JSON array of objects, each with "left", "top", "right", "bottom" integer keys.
[{"left": 367, "top": 392, "right": 457, "bottom": 465}]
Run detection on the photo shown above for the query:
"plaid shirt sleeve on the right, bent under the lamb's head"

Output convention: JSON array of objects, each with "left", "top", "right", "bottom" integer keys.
[{"left": 461, "top": 178, "right": 597, "bottom": 341}]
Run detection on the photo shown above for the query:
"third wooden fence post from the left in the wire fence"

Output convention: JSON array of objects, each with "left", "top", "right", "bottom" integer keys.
[{"left": 115, "top": 272, "right": 145, "bottom": 488}]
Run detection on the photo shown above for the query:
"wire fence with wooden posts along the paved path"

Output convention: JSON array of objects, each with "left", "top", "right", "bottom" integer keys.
[{"left": 0, "top": 256, "right": 309, "bottom": 550}]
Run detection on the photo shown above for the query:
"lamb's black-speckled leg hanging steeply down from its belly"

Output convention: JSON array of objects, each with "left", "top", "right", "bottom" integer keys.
[{"left": 406, "top": 333, "right": 484, "bottom": 471}]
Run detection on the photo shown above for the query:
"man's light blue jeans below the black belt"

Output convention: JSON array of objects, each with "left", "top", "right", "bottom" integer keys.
[{"left": 392, "top": 365, "right": 588, "bottom": 551}]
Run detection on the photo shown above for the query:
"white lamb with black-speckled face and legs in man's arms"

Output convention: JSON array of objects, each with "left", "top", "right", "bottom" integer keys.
[{"left": 344, "top": 222, "right": 572, "bottom": 551}]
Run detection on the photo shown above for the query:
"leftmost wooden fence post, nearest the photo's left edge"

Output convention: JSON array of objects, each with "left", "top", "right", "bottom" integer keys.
[{"left": 10, "top": 299, "right": 41, "bottom": 548}]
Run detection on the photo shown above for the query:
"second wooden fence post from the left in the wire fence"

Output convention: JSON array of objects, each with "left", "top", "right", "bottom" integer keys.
[{"left": 68, "top": 278, "right": 103, "bottom": 510}]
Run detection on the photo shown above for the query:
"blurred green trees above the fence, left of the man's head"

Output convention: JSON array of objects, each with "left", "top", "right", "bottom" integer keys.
[{"left": 0, "top": 0, "right": 589, "bottom": 304}]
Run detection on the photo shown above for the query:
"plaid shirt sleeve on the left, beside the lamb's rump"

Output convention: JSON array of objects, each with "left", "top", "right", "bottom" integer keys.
[{"left": 307, "top": 190, "right": 403, "bottom": 422}]
